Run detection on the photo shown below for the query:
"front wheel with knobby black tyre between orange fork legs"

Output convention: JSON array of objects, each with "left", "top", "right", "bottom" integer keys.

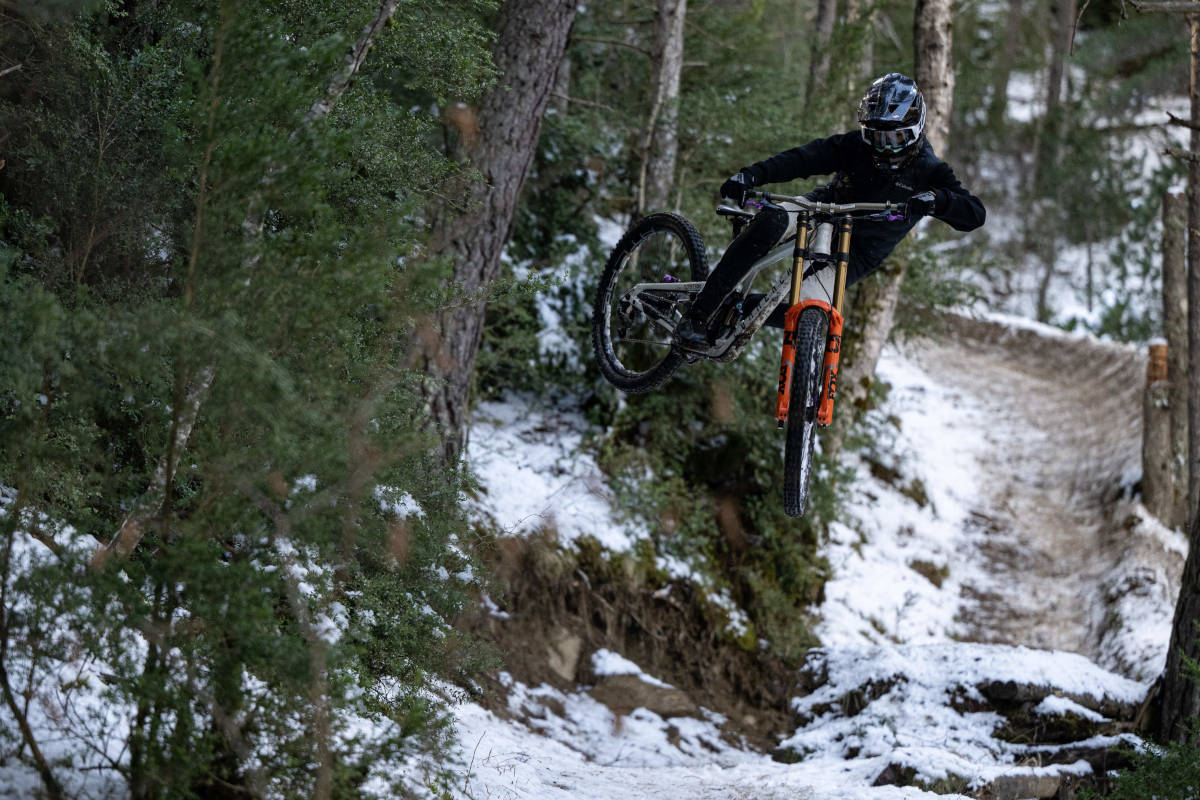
[{"left": 784, "top": 307, "right": 829, "bottom": 517}]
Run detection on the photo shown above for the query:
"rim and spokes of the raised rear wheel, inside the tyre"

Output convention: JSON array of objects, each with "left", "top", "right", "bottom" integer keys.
[{"left": 604, "top": 229, "right": 691, "bottom": 375}]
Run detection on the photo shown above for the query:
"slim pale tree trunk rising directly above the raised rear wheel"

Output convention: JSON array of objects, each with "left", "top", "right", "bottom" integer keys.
[{"left": 637, "top": 0, "right": 688, "bottom": 216}]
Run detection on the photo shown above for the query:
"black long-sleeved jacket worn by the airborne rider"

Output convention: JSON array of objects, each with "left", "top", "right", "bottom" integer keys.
[{"left": 742, "top": 130, "right": 986, "bottom": 283}]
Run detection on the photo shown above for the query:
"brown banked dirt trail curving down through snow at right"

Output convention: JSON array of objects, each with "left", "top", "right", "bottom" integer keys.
[{"left": 905, "top": 317, "right": 1145, "bottom": 660}]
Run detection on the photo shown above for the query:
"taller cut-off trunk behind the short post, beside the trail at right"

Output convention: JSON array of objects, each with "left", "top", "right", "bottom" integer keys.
[{"left": 1163, "top": 193, "right": 1189, "bottom": 530}]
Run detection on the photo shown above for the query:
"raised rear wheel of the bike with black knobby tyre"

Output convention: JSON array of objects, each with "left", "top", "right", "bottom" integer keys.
[{"left": 592, "top": 213, "right": 708, "bottom": 392}]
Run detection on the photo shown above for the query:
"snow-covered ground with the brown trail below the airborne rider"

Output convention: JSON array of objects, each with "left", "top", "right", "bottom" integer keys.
[{"left": 456, "top": 311, "right": 1183, "bottom": 799}]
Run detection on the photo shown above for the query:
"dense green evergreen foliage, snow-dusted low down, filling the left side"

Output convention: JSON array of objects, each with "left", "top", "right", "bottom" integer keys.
[{"left": 0, "top": 0, "right": 491, "bottom": 798}]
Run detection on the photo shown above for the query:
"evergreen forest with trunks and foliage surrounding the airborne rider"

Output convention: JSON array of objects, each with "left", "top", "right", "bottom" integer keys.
[{"left": 0, "top": 0, "right": 1188, "bottom": 798}]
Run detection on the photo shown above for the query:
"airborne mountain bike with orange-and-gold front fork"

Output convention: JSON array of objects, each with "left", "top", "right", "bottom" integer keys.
[{"left": 592, "top": 192, "right": 905, "bottom": 517}]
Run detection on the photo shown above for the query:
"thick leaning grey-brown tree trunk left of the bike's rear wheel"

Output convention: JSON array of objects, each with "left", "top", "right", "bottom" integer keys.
[{"left": 416, "top": 0, "right": 576, "bottom": 461}]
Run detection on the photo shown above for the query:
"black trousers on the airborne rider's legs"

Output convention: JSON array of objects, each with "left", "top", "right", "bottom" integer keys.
[{"left": 690, "top": 207, "right": 882, "bottom": 327}]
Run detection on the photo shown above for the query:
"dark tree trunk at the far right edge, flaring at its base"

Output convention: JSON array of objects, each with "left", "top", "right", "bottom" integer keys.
[{"left": 1158, "top": 5, "right": 1200, "bottom": 741}]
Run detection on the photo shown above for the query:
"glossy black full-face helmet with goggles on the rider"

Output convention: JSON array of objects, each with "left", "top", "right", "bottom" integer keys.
[{"left": 858, "top": 72, "right": 925, "bottom": 170}]
